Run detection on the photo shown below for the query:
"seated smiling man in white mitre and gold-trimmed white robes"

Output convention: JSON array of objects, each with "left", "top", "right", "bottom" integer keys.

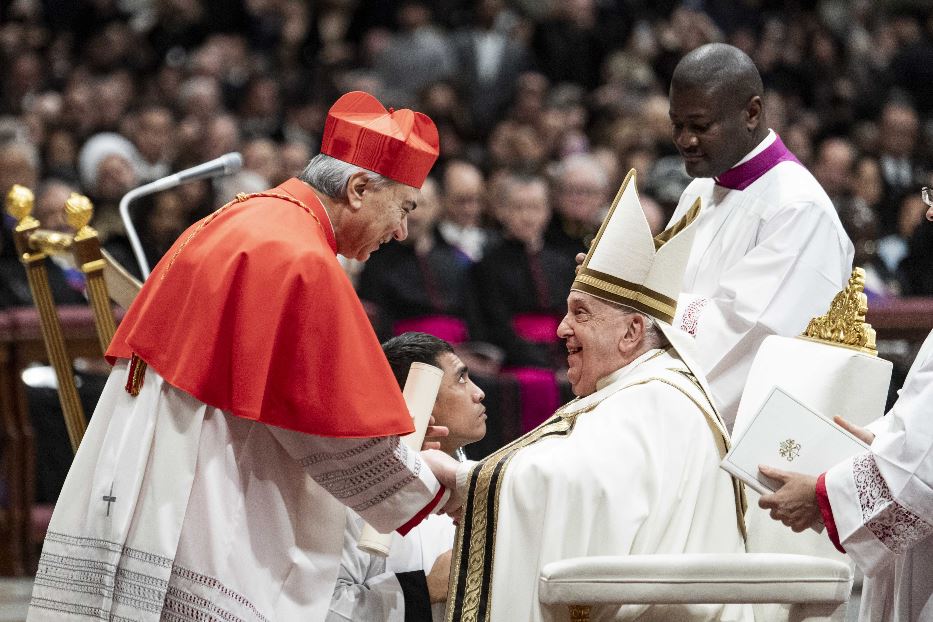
[{"left": 447, "top": 171, "right": 750, "bottom": 622}]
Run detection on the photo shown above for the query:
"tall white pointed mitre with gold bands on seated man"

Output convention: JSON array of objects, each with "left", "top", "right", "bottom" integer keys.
[{"left": 571, "top": 169, "right": 700, "bottom": 324}]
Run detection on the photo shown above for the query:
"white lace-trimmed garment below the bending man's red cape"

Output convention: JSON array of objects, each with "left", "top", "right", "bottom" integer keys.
[{"left": 28, "top": 360, "right": 443, "bottom": 622}]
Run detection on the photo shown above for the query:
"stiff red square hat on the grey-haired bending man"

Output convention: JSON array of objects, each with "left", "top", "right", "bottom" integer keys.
[{"left": 321, "top": 91, "right": 438, "bottom": 188}]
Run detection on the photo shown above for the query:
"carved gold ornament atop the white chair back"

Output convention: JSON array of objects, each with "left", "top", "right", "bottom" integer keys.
[{"left": 801, "top": 268, "right": 878, "bottom": 356}]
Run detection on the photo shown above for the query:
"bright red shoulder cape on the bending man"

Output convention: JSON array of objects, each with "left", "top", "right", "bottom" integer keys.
[{"left": 107, "top": 179, "right": 413, "bottom": 438}]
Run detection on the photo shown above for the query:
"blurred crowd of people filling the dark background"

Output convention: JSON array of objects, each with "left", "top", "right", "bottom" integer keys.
[{"left": 0, "top": 0, "right": 933, "bottom": 404}]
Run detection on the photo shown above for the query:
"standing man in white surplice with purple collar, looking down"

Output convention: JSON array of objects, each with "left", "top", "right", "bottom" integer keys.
[{"left": 670, "top": 43, "right": 854, "bottom": 429}]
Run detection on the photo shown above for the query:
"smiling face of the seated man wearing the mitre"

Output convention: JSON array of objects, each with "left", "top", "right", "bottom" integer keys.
[{"left": 557, "top": 291, "right": 631, "bottom": 397}]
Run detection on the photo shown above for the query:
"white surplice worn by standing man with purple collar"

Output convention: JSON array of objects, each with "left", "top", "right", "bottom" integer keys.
[{"left": 670, "top": 131, "right": 854, "bottom": 430}]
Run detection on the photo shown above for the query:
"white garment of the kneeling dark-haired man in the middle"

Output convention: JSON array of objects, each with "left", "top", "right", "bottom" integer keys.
[{"left": 327, "top": 512, "right": 456, "bottom": 622}]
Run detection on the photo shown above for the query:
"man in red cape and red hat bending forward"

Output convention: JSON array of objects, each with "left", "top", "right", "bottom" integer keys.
[{"left": 29, "top": 92, "right": 457, "bottom": 621}]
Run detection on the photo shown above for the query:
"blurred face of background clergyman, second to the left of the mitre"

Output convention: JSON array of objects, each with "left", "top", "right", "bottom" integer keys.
[{"left": 499, "top": 176, "right": 551, "bottom": 251}]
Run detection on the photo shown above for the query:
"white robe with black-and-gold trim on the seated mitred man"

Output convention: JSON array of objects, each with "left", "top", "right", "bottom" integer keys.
[{"left": 448, "top": 350, "right": 751, "bottom": 622}]
